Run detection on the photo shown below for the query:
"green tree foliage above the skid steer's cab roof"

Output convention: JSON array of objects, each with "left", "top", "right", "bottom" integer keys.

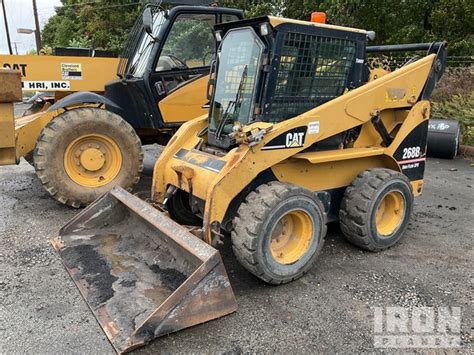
[{"left": 224, "top": 0, "right": 474, "bottom": 55}]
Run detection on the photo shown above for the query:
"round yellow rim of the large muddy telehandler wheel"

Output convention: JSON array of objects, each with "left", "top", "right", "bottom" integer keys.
[{"left": 64, "top": 134, "right": 122, "bottom": 187}]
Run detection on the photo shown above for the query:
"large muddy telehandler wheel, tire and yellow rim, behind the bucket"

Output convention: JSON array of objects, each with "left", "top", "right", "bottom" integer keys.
[{"left": 34, "top": 108, "right": 143, "bottom": 208}]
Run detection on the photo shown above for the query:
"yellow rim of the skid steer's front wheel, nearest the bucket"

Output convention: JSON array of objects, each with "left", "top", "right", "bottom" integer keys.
[{"left": 270, "top": 210, "right": 313, "bottom": 265}]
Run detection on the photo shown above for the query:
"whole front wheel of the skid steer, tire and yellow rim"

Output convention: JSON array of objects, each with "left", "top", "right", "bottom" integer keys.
[{"left": 231, "top": 182, "right": 326, "bottom": 285}]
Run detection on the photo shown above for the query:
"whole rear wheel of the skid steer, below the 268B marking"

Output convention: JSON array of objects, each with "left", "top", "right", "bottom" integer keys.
[{"left": 339, "top": 169, "right": 413, "bottom": 252}]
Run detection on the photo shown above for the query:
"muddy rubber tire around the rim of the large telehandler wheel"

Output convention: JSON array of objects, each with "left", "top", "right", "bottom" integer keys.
[{"left": 34, "top": 108, "right": 143, "bottom": 208}]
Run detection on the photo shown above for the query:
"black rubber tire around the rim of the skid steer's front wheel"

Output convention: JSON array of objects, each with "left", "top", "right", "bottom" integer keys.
[{"left": 231, "top": 182, "right": 326, "bottom": 285}]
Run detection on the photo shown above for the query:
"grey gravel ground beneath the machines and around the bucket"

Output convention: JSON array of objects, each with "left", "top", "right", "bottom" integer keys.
[{"left": 0, "top": 147, "right": 474, "bottom": 354}]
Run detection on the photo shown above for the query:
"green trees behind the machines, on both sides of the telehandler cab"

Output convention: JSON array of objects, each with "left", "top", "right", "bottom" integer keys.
[{"left": 43, "top": 0, "right": 474, "bottom": 55}]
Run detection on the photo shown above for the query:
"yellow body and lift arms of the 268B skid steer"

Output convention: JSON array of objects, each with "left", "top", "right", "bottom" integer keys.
[{"left": 152, "top": 55, "right": 435, "bottom": 242}]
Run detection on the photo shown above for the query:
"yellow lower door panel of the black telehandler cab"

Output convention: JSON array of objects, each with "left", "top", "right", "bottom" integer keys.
[{"left": 158, "top": 75, "right": 209, "bottom": 123}]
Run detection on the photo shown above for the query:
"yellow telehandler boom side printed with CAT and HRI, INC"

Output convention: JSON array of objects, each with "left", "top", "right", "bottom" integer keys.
[{"left": 0, "top": 55, "right": 118, "bottom": 92}]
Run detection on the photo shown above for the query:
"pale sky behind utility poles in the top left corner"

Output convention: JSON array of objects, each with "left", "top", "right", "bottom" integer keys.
[{"left": 0, "top": 0, "right": 61, "bottom": 54}]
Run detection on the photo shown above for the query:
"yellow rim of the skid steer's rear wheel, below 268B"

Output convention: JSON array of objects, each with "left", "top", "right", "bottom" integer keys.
[{"left": 375, "top": 191, "right": 405, "bottom": 237}]
